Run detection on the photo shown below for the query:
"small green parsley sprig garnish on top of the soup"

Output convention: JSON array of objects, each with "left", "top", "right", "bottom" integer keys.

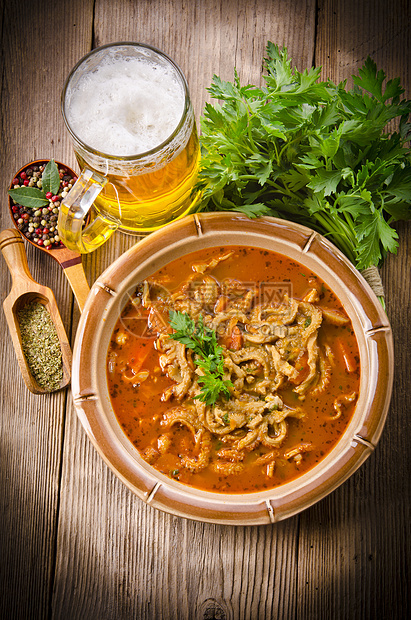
[{"left": 170, "top": 310, "right": 232, "bottom": 405}]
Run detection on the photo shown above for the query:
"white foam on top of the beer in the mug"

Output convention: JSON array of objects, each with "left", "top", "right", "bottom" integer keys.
[{"left": 65, "top": 57, "right": 185, "bottom": 156}]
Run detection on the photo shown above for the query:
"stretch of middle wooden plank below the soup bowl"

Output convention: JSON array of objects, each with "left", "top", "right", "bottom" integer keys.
[{"left": 53, "top": 398, "right": 298, "bottom": 620}]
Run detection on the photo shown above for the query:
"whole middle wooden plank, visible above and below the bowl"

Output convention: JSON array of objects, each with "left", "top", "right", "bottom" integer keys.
[{"left": 52, "top": 0, "right": 314, "bottom": 620}]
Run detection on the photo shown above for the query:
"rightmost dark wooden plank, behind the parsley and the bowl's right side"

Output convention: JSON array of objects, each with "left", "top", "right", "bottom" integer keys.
[{"left": 297, "top": 0, "right": 411, "bottom": 620}]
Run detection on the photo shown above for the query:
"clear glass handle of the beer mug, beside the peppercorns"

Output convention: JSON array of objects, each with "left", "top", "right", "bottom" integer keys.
[{"left": 57, "top": 168, "right": 118, "bottom": 254}]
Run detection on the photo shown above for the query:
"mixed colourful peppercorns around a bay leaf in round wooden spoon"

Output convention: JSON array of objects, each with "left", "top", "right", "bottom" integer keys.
[{"left": 11, "top": 165, "right": 77, "bottom": 250}]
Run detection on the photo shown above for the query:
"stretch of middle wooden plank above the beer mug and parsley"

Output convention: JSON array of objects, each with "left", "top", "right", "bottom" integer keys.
[{"left": 95, "top": 0, "right": 315, "bottom": 119}]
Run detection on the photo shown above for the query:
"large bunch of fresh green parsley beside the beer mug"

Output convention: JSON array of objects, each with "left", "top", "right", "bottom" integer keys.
[{"left": 197, "top": 42, "right": 411, "bottom": 270}]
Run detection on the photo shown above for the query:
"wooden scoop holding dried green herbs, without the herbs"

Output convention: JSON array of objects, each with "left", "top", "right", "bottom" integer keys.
[{"left": 0, "top": 229, "right": 72, "bottom": 394}]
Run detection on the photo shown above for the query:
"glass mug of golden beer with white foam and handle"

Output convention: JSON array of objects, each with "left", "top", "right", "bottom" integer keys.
[{"left": 58, "top": 42, "right": 200, "bottom": 253}]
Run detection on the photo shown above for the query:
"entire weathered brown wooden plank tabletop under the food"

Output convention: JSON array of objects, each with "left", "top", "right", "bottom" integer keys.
[{"left": 0, "top": 0, "right": 411, "bottom": 620}]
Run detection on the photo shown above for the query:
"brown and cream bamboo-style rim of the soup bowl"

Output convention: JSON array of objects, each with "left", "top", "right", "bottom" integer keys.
[{"left": 72, "top": 212, "right": 393, "bottom": 525}]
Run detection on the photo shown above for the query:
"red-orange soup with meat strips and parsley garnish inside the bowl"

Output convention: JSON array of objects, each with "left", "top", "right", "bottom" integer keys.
[{"left": 107, "top": 246, "right": 360, "bottom": 493}]
